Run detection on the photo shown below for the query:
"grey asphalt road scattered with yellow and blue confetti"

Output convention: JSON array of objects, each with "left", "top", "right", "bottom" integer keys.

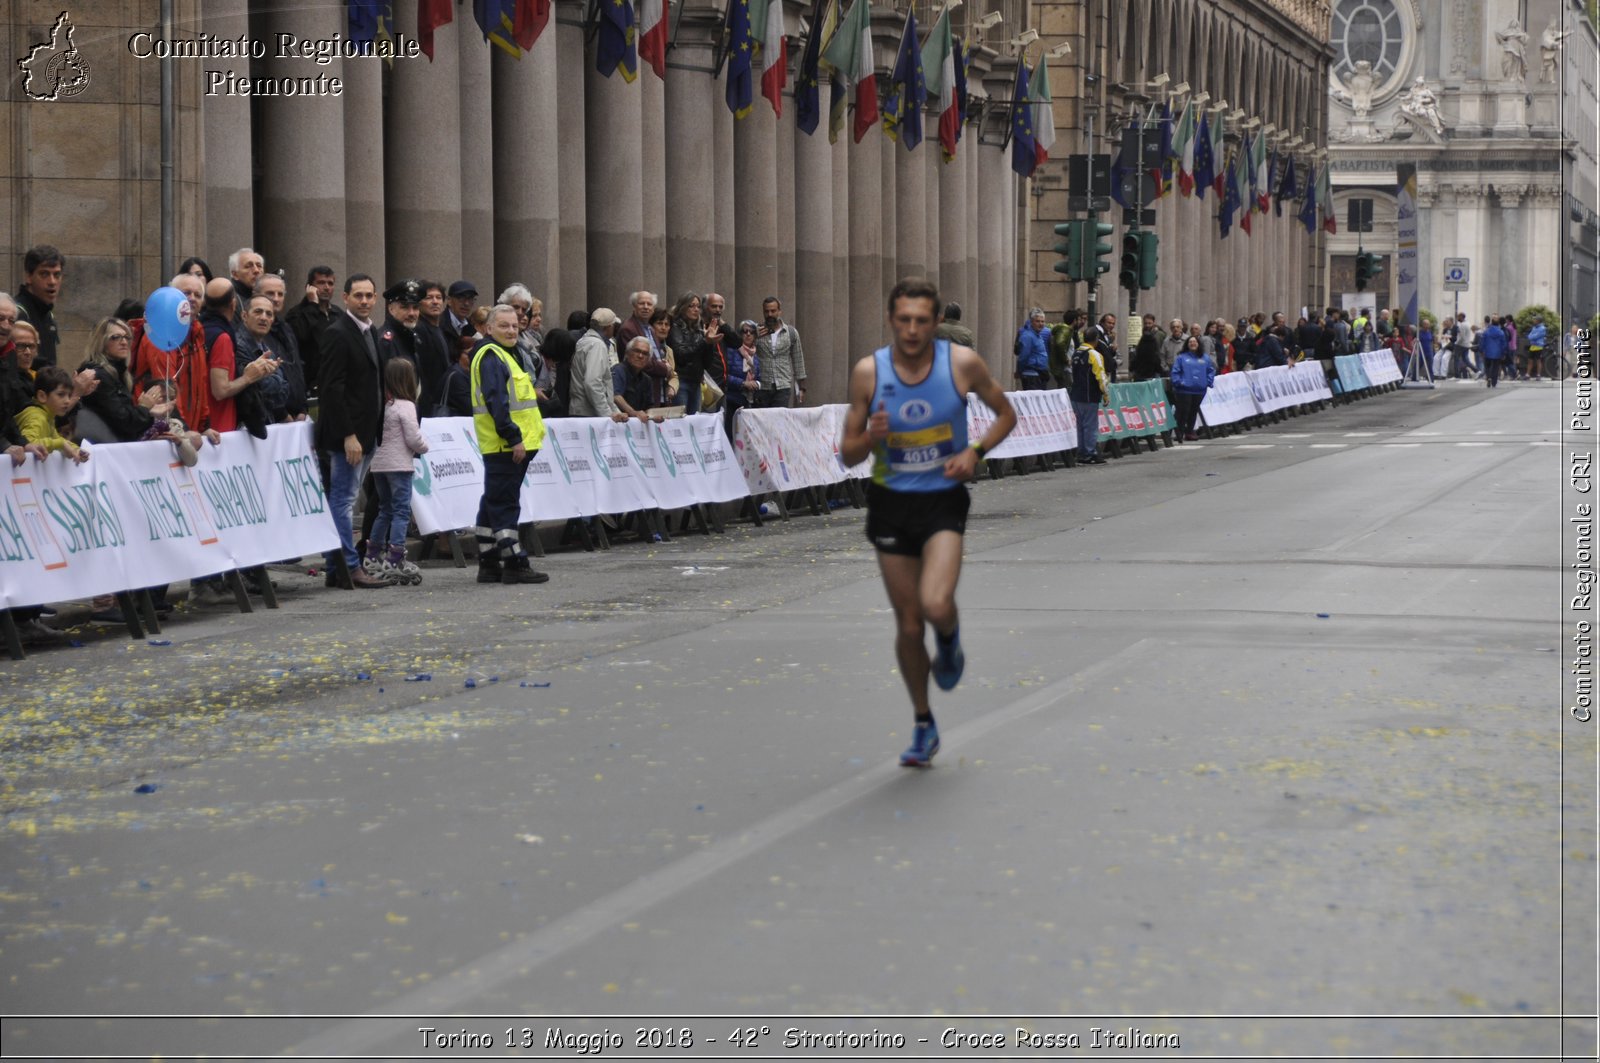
[{"left": 0, "top": 377, "right": 1597, "bottom": 1058}]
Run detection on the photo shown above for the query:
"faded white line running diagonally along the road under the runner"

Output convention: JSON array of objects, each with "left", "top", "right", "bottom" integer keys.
[{"left": 285, "top": 639, "right": 1149, "bottom": 1057}]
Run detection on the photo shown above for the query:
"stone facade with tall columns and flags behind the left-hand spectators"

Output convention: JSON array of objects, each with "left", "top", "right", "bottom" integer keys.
[{"left": 0, "top": 0, "right": 1068, "bottom": 402}]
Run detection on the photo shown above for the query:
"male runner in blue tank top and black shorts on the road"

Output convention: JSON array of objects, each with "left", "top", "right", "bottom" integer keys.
[{"left": 840, "top": 279, "right": 1016, "bottom": 767}]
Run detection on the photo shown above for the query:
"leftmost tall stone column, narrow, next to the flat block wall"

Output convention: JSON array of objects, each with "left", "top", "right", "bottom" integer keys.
[{"left": 201, "top": 0, "right": 251, "bottom": 257}]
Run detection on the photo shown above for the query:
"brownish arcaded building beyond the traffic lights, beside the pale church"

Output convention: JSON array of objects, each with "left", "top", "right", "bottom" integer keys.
[{"left": 1024, "top": 0, "right": 1331, "bottom": 337}]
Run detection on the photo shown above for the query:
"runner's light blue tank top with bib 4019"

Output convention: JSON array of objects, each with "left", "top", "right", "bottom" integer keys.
[{"left": 870, "top": 339, "right": 966, "bottom": 491}]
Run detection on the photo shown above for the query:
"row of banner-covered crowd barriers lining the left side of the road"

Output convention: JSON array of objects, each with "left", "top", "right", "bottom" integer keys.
[{"left": 0, "top": 369, "right": 1400, "bottom": 624}]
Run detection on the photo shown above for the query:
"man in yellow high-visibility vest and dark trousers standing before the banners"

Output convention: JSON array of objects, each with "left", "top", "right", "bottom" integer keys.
[{"left": 470, "top": 303, "right": 550, "bottom": 583}]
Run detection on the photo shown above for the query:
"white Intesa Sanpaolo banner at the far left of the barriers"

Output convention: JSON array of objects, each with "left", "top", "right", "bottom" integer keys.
[{"left": 0, "top": 421, "right": 339, "bottom": 607}]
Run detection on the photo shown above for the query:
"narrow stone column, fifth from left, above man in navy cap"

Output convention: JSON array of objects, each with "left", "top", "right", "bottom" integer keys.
[{"left": 457, "top": 20, "right": 502, "bottom": 292}]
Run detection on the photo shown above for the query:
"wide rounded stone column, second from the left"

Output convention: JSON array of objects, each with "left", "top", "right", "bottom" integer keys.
[{"left": 257, "top": 0, "right": 350, "bottom": 278}]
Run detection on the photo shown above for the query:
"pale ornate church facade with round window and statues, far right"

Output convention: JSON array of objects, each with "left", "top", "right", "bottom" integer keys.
[{"left": 1326, "top": 0, "right": 1597, "bottom": 322}]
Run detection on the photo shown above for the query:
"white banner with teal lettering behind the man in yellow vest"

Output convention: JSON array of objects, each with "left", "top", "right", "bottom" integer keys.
[{"left": 411, "top": 413, "right": 747, "bottom": 535}]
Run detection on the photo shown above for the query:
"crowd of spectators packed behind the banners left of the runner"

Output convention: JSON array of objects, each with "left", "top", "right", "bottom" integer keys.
[{"left": 0, "top": 245, "right": 806, "bottom": 644}]
